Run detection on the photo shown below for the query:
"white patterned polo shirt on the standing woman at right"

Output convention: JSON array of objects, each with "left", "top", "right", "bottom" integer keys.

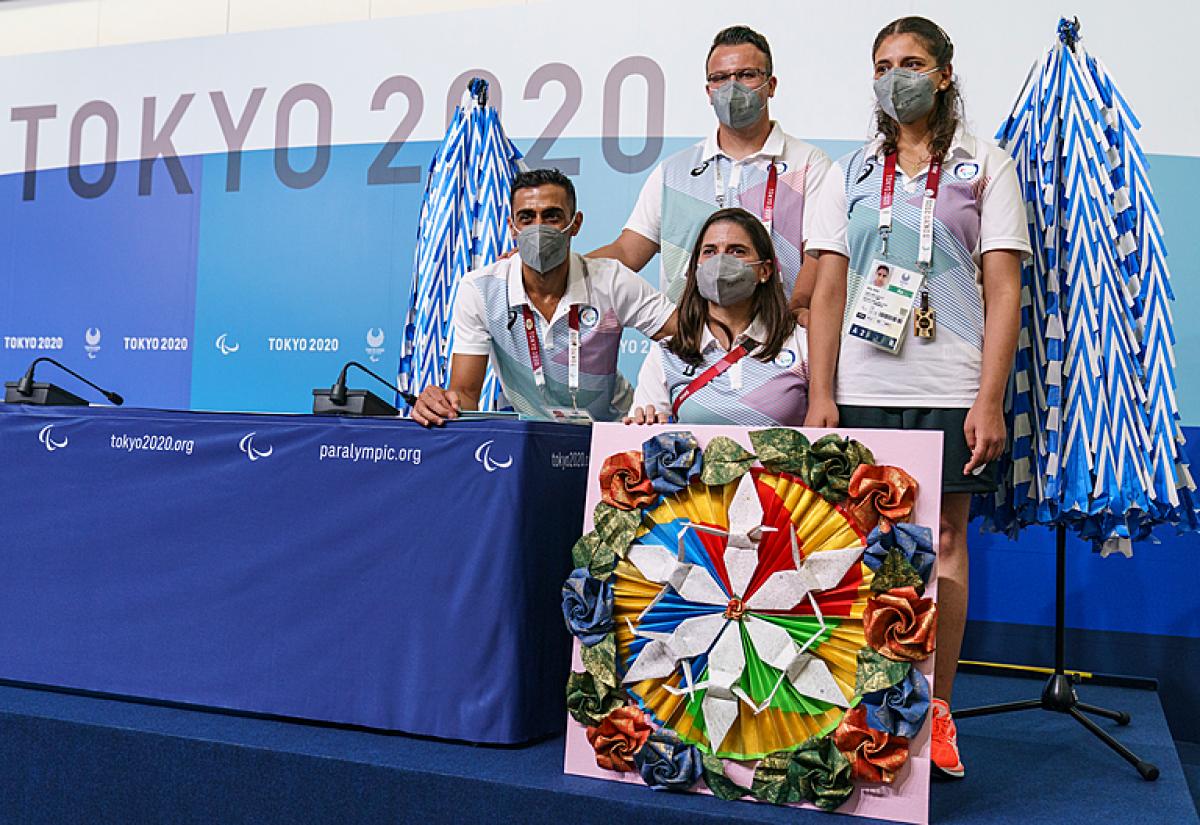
[{"left": 809, "top": 132, "right": 1030, "bottom": 408}]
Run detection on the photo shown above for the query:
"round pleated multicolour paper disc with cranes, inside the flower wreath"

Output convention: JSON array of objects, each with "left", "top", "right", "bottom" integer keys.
[{"left": 613, "top": 469, "right": 872, "bottom": 759}]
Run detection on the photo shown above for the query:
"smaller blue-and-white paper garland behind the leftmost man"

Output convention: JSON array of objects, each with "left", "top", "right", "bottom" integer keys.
[{"left": 398, "top": 78, "right": 523, "bottom": 410}]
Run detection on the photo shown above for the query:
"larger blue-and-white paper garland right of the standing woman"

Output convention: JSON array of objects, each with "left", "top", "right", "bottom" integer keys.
[{"left": 976, "top": 20, "right": 1200, "bottom": 550}]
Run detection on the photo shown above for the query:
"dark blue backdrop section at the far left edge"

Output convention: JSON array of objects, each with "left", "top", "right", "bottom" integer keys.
[{"left": 0, "top": 159, "right": 200, "bottom": 409}]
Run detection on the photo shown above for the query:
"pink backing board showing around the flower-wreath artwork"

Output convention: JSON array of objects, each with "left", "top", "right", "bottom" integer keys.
[{"left": 563, "top": 423, "right": 942, "bottom": 825}]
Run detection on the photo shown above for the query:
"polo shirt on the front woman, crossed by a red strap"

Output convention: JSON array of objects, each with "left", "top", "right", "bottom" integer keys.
[{"left": 634, "top": 319, "right": 809, "bottom": 427}]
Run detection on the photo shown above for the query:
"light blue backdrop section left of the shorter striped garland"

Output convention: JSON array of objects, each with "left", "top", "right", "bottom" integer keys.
[{"left": 192, "top": 143, "right": 433, "bottom": 413}]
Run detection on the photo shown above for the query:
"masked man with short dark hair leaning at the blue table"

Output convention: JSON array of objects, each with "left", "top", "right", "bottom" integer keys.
[{"left": 413, "top": 169, "right": 674, "bottom": 426}]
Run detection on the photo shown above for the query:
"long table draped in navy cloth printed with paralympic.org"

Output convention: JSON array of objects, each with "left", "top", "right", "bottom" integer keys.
[{"left": 0, "top": 405, "right": 589, "bottom": 743}]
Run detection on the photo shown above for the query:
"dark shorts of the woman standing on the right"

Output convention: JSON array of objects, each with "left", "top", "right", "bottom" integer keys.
[{"left": 838, "top": 404, "right": 996, "bottom": 493}]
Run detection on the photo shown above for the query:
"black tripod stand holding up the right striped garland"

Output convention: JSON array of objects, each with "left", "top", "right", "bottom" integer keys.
[{"left": 954, "top": 524, "right": 1158, "bottom": 782}]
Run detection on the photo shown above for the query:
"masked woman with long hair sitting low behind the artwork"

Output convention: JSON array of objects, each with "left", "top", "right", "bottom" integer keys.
[{"left": 625, "top": 209, "right": 809, "bottom": 427}]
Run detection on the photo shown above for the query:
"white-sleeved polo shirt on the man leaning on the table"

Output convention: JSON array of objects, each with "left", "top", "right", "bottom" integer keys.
[{"left": 454, "top": 253, "right": 674, "bottom": 421}]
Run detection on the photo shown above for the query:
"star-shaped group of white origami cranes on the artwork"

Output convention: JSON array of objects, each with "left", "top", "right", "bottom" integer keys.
[{"left": 624, "top": 474, "right": 863, "bottom": 752}]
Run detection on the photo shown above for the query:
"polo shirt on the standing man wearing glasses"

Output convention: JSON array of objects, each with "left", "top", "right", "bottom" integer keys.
[{"left": 625, "top": 122, "right": 830, "bottom": 302}]
